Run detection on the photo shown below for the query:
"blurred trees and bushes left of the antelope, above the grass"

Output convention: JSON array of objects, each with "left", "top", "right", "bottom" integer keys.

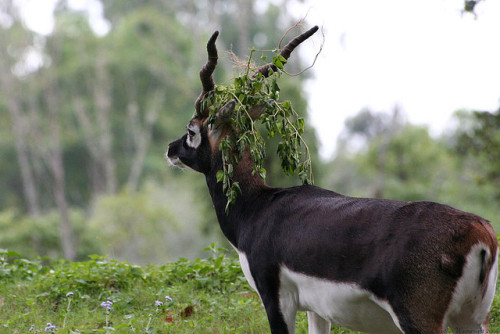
[{"left": 0, "top": 1, "right": 317, "bottom": 263}]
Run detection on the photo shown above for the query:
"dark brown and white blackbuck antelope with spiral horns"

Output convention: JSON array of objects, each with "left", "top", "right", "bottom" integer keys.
[{"left": 167, "top": 27, "right": 498, "bottom": 333}]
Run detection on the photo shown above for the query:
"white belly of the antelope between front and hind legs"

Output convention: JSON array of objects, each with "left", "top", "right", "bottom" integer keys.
[{"left": 280, "top": 267, "right": 402, "bottom": 333}]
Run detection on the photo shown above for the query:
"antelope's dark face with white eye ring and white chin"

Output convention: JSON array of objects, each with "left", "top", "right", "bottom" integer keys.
[{"left": 166, "top": 118, "right": 211, "bottom": 174}]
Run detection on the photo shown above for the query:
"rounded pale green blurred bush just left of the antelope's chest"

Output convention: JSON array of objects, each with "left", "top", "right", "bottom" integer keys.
[{"left": 87, "top": 181, "right": 214, "bottom": 264}]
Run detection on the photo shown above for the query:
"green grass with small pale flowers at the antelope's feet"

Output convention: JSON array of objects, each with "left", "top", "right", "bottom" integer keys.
[{"left": 0, "top": 245, "right": 500, "bottom": 333}]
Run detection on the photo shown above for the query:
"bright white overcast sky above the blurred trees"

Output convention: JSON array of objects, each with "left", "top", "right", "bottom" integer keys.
[{"left": 13, "top": 0, "right": 500, "bottom": 158}]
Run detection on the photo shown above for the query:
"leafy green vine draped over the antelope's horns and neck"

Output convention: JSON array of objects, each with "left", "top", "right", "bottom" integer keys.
[{"left": 200, "top": 27, "right": 321, "bottom": 213}]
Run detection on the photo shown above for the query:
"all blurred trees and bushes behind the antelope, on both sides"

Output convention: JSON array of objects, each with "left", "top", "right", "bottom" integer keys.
[{"left": 0, "top": 0, "right": 500, "bottom": 263}]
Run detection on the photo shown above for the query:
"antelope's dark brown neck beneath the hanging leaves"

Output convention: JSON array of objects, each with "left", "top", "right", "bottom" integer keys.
[{"left": 206, "top": 151, "right": 269, "bottom": 246}]
